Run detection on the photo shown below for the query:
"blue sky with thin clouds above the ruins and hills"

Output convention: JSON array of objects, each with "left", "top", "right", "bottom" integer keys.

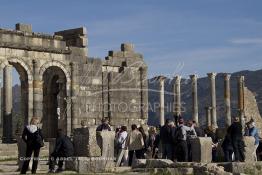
[{"left": 0, "top": 0, "right": 262, "bottom": 84}]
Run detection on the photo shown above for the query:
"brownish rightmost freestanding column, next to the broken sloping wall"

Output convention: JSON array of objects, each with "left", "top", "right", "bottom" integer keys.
[{"left": 237, "top": 76, "right": 245, "bottom": 128}]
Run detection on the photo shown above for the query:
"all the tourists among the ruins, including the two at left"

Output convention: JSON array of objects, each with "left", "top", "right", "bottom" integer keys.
[{"left": 18, "top": 117, "right": 259, "bottom": 174}]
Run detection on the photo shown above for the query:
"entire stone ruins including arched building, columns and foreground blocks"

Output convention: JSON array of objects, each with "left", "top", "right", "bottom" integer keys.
[{"left": 0, "top": 24, "right": 262, "bottom": 174}]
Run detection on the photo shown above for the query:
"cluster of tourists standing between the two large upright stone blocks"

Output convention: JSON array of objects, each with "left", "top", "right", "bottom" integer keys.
[{"left": 115, "top": 118, "right": 202, "bottom": 166}]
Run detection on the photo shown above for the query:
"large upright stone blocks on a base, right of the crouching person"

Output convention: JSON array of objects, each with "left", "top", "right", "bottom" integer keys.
[{"left": 65, "top": 127, "right": 115, "bottom": 173}]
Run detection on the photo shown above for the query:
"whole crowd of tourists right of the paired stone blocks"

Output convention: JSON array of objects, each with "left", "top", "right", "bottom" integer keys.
[{"left": 115, "top": 117, "right": 259, "bottom": 166}]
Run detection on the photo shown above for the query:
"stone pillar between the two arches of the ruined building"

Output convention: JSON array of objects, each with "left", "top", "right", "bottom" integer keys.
[{"left": 32, "top": 60, "right": 43, "bottom": 123}]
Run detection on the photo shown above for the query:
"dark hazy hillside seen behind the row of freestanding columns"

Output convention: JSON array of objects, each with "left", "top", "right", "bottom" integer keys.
[{"left": 148, "top": 70, "right": 262, "bottom": 127}]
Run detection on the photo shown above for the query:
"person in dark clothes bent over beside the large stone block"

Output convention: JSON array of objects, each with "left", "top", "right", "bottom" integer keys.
[{"left": 49, "top": 129, "right": 74, "bottom": 173}]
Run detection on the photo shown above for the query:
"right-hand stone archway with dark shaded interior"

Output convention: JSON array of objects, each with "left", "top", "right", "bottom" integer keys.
[{"left": 39, "top": 62, "right": 71, "bottom": 138}]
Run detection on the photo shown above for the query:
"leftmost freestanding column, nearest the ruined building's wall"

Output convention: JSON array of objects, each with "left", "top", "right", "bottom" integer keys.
[{"left": 157, "top": 76, "right": 166, "bottom": 126}]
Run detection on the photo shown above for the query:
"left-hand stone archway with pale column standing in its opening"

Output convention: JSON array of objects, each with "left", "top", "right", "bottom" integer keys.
[{"left": 0, "top": 58, "right": 33, "bottom": 142}]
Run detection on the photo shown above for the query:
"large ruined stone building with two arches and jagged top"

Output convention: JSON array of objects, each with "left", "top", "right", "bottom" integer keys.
[{"left": 0, "top": 24, "right": 148, "bottom": 142}]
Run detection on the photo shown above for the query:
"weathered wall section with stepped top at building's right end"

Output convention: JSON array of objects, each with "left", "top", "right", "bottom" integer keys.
[{"left": 102, "top": 44, "right": 148, "bottom": 125}]
